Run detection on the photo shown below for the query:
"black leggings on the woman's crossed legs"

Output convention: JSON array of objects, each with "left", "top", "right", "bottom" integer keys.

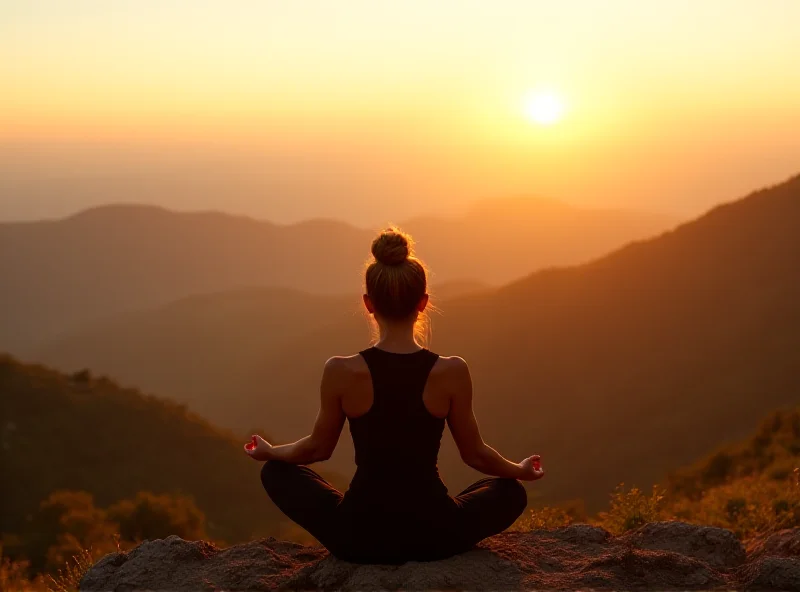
[{"left": 261, "top": 461, "right": 528, "bottom": 564}]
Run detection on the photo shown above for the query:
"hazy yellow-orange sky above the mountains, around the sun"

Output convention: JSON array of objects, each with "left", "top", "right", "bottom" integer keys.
[{"left": 0, "top": 0, "right": 800, "bottom": 224}]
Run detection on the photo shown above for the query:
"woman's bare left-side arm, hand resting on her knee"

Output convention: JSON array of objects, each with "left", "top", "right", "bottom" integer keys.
[{"left": 245, "top": 358, "right": 345, "bottom": 465}]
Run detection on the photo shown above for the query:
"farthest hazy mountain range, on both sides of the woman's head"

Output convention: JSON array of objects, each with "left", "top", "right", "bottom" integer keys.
[{"left": 0, "top": 200, "right": 675, "bottom": 355}]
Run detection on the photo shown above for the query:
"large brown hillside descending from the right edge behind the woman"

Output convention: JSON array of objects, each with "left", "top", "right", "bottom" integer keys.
[{"left": 222, "top": 177, "right": 800, "bottom": 508}]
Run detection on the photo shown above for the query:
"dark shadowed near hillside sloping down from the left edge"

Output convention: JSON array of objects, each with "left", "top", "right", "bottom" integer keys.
[{"left": 0, "top": 355, "right": 283, "bottom": 541}]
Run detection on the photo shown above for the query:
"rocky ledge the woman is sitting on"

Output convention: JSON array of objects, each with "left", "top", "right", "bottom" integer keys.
[{"left": 80, "top": 522, "right": 800, "bottom": 592}]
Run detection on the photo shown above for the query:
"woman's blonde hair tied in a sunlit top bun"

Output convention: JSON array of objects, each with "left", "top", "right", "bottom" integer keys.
[{"left": 364, "top": 226, "right": 430, "bottom": 343}]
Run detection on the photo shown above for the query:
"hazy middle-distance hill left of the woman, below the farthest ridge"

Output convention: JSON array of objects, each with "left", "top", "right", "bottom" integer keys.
[{"left": 36, "top": 281, "right": 488, "bottom": 418}]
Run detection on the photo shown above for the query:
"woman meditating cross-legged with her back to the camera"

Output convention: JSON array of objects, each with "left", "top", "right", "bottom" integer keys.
[{"left": 245, "top": 229, "right": 544, "bottom": 564}]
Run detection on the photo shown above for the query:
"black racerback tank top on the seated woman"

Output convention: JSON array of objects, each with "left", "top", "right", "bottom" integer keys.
[{"left": 347, "top": 347, "right": 447, "bottom": 500}]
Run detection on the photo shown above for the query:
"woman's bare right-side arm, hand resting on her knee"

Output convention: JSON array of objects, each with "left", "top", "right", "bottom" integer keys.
[{"left": 447, "top": 358, "right": 544, "bottom": 481}]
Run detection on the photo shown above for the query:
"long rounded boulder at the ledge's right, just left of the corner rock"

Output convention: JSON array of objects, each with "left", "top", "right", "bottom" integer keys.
[{"left": 620, "top": 522, "right": 746, "bottom": 568}]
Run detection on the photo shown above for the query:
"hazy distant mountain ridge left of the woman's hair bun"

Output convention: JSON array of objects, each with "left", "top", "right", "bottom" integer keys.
[{"left": 0, "top": 206, "right": 369, "bottom": 352}]
